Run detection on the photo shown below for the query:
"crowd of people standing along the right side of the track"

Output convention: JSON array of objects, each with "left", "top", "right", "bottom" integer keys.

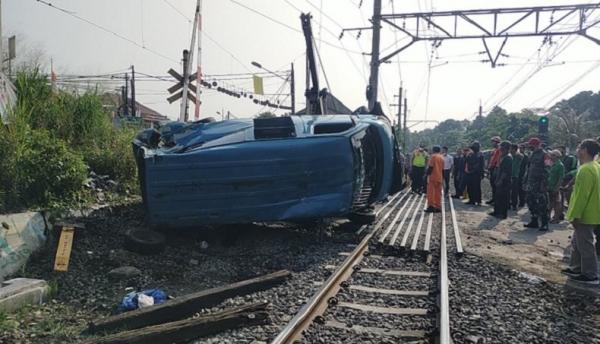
[{"left": 409, "top": 136, "right": 600, "bottom": 284}]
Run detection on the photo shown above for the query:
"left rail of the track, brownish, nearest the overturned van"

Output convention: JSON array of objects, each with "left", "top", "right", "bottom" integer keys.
[{"left": 271, "top": 191, "right": 402, "bottom": 344}]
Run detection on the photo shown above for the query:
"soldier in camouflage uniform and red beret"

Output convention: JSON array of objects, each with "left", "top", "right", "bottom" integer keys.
[{"left": 524, "top": 137, "right": 548, "bottom": 232}]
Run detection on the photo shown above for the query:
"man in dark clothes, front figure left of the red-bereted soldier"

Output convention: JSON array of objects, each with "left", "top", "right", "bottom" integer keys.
[{"left": 489, "top": 141, "right": 513, "bottom": 219}]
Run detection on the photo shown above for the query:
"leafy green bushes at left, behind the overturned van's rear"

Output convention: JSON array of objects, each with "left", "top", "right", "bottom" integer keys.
[{"left": 0, "top": 69, "right": 136, "bottom": 212}]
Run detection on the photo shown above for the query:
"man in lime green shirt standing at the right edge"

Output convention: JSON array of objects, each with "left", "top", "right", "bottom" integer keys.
[{"left": 562, "top": 140, "right": 600, "bottom": 285}]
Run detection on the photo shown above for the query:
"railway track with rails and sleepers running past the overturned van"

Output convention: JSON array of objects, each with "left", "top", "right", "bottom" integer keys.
[{"left": 272, "top": 191, "right": 463, "bottom": 344}]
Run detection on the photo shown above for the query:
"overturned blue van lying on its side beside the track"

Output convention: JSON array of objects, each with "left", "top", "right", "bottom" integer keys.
[{"left": 133, "top": 115, "right": 400, "bottom": 227}]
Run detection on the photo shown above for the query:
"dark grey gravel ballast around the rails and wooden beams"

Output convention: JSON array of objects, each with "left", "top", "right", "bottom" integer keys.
[{"left": 0, "top": 196, "right": 600, "bottom": 344}]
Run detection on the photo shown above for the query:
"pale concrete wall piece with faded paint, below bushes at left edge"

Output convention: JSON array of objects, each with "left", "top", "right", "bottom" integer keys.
[{"left": 0, "top": 212, "right": 46, "bottom": 282}]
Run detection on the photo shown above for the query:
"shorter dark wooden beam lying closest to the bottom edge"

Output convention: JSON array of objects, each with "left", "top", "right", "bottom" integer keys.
[{"left": 88, "top": 303, "right": 269, "bottom": 344}]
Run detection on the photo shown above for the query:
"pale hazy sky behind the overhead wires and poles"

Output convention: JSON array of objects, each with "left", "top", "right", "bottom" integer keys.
[{"left": 2, "top": 0, "right": 600, "bottom": 129}]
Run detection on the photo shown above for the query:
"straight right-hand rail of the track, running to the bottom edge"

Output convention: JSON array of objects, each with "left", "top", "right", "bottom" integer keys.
[{"left": 439, "top": 197, "right": 451, "bottom": 344}]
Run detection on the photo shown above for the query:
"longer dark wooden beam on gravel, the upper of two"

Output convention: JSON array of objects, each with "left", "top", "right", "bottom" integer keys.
[{"left": 88, "top": 270, "right": 290, "bottom": 333}]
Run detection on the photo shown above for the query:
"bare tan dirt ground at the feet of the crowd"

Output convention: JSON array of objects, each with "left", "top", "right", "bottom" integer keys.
[{"left": 454, "top": 200, "right": 600, "bottom": 294}]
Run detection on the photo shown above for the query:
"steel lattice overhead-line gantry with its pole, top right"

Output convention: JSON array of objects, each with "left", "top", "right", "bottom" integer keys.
[{"left": 342, "top": 0, "right": 600, "bottom": 109}]
